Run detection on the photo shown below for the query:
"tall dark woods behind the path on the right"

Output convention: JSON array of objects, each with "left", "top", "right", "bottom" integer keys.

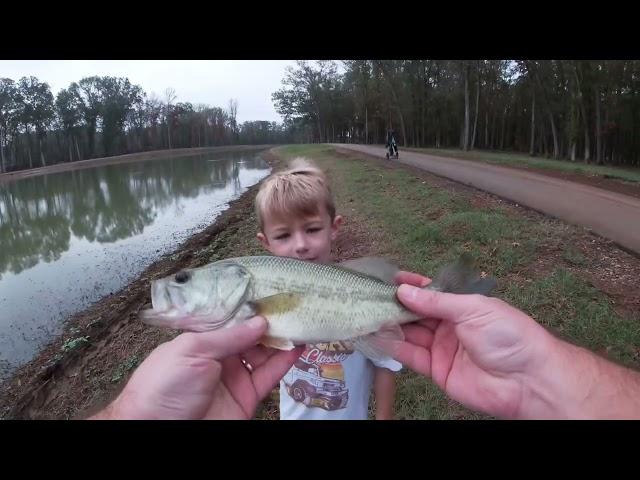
[{"left": 272, "top": 60, "right": 640, "bottom": 166}]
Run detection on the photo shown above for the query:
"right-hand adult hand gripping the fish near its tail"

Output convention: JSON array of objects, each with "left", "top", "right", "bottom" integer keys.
[{"left": 394, "top": 272, "right": 557, "bottom": 417}]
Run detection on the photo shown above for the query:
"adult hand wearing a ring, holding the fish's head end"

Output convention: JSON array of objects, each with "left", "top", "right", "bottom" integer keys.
[{"left": 93, "top": 317, "right": 302, "bottom": 420}]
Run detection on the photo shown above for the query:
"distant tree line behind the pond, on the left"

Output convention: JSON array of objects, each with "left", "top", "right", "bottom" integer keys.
[{"left": 0, "top": 76, "right": 290, "bottom": 173}]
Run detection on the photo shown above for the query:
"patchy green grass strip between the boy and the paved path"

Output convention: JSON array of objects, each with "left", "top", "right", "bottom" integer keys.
[{"left": 268, "top": 145, "right": 640, "bottom": 419}]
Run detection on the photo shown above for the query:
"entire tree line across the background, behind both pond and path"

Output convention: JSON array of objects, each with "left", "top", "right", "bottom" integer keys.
[{"left": 0, "top": 60, "right": 640, "bottom": 172}]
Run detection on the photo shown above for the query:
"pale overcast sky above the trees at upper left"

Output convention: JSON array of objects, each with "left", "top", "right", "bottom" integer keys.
[{"left": 0, "top": 60, "right": 295, "bottom": 123}]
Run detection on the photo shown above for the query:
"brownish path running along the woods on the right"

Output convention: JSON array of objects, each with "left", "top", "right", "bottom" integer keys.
[{"left": 335, "top": 144, "right": 640, "bottom": 254}]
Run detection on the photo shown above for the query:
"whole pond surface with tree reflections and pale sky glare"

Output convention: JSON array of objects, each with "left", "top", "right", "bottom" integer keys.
[{"left": 0, "top": 152, "right": 268, "bottom": 378}]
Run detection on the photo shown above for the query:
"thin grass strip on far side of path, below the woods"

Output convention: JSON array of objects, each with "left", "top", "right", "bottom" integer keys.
[{"left": 406, "top": 148, "right": 640, "bottom": 183}]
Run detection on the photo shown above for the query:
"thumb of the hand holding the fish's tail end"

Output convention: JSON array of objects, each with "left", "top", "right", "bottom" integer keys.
[{"left": 397, "top": 284, "right": 480, "bottom": 323}]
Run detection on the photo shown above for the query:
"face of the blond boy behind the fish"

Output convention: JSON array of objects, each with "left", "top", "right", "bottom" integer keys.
[{"left": 258, "top": 207, "right": 342, "bottom": 263}]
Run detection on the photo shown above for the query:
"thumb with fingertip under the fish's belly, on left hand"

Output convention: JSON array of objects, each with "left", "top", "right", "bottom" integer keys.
[{"left": 176, "top": 317, "right": 267, "bottom": 360}]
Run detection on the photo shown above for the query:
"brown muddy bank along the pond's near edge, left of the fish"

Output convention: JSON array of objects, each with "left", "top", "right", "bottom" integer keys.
[{"left": 0, "top": 147, "right": 277, "bottom": 419}]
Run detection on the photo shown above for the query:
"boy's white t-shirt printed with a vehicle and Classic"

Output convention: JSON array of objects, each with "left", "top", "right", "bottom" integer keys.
[{"left": 280, "top": 342, "right": 402, "bottom": 420}]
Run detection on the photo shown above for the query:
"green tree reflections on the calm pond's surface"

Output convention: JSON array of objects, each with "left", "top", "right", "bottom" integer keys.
[{"left": 0, "top": 155, "right": 265, "bottom": 278}]
